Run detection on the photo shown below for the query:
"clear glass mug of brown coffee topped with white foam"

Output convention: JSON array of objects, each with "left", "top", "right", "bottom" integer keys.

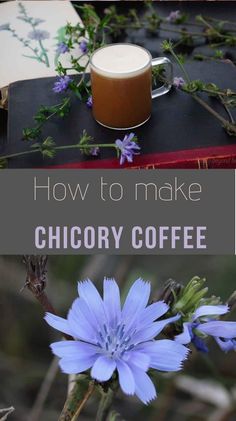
[{"left": 90, "top": 43, "right": 173, "bottom": 130}]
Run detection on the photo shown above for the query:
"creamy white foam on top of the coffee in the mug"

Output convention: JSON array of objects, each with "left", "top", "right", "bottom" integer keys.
[{"left": 92, "top": 44, "right": 150, "bottom": 78}]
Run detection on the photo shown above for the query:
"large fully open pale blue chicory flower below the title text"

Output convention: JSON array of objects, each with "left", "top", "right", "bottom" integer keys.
[{"left": 45, "top": 279, "right": 188, "bottom": 404}]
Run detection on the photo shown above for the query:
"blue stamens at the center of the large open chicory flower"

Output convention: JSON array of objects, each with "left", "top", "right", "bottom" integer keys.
[{"left": 97, "top": 323, "right": 135, "bottom": 358}]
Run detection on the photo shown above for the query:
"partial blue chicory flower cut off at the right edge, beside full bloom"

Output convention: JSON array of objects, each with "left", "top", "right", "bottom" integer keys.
[{"left": 175, "top": 305, "right": 236, "bottom": 352}]
